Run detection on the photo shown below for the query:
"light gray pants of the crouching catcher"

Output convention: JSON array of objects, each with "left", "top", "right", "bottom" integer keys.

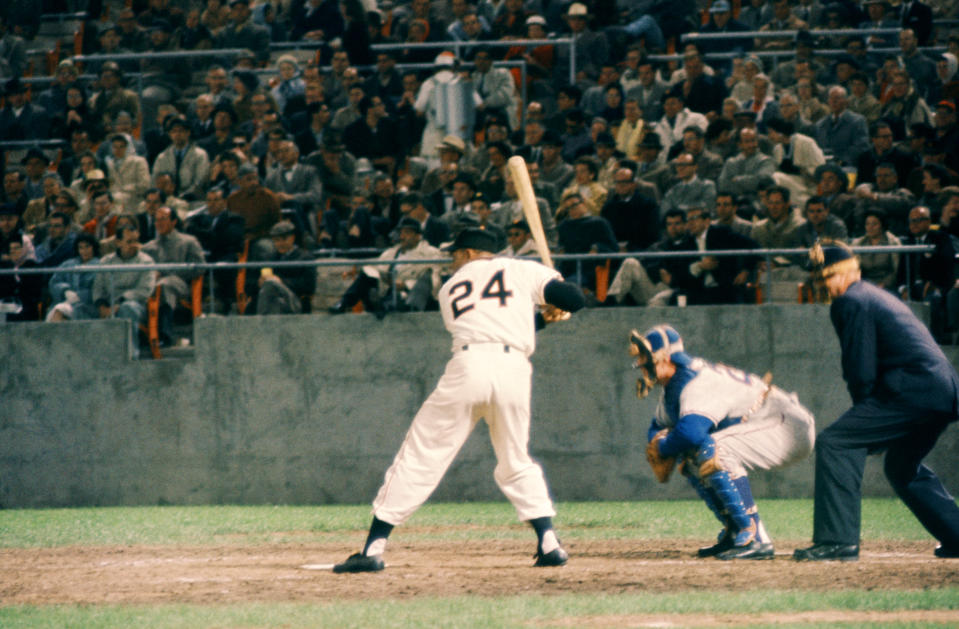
[{"left": 713, "top": 387, "right": 816, "bottom": 478}]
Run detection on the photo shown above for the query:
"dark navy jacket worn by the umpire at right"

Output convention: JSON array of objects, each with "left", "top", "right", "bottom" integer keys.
[{"left": 830, "top": 281, "right": 959, "bottom": 414}]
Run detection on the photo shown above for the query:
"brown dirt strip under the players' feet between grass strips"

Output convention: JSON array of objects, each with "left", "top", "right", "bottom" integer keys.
[{"left": 0, "top": 539, "right": 959, "bottom": 604}]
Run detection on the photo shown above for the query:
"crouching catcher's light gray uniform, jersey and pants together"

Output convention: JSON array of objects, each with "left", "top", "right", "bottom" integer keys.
[{"left": 656, "top": 358, "right": 816, "bottom": 478}]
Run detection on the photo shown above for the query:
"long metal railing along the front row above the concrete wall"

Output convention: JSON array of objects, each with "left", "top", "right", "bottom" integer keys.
[{"left": 0, "top": 245, "right": 935, "bottom": 316}]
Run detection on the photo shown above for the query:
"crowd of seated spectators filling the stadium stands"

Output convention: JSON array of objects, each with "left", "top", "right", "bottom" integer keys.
[{"left": 0, "top": 0, "right": 959, "bottom": 343}]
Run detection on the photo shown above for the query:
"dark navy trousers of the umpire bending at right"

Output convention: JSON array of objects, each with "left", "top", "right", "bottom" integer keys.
[{"left": 813, "top": 398, "right": 959, "bottom": 549}]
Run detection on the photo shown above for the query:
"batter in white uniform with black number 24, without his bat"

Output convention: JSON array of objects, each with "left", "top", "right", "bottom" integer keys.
[{"left": 333, "top": 229, "right": 585, "bottom": 572}]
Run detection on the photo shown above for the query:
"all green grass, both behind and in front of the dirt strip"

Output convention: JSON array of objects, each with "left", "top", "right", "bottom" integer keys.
[{"left": 0, "top": 499, "right": 959, "bottom": 629}]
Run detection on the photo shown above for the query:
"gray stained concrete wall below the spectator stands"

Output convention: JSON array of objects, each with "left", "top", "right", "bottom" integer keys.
[{"left": 0, "top": 306, "right": 959, "bottom": 508}]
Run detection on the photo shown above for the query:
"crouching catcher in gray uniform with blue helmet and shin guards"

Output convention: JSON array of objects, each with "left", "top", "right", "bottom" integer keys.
[{"left": 629, "top": 325, "right": 816, "bottom": 560}]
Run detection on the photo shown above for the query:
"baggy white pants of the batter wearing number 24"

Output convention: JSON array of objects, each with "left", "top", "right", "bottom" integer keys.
[{"left": 373, "top": 343, "right": 556, "bottom": 525}]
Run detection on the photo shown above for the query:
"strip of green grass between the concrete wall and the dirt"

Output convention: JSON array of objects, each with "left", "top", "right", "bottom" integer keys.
[{"left": 0, "top": 499, "right": 930, "bottom": 548}]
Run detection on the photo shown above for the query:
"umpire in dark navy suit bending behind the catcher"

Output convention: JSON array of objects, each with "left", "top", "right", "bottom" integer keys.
[{"left": 793, "top": 243, "right": 959, "bottom": 561}]
